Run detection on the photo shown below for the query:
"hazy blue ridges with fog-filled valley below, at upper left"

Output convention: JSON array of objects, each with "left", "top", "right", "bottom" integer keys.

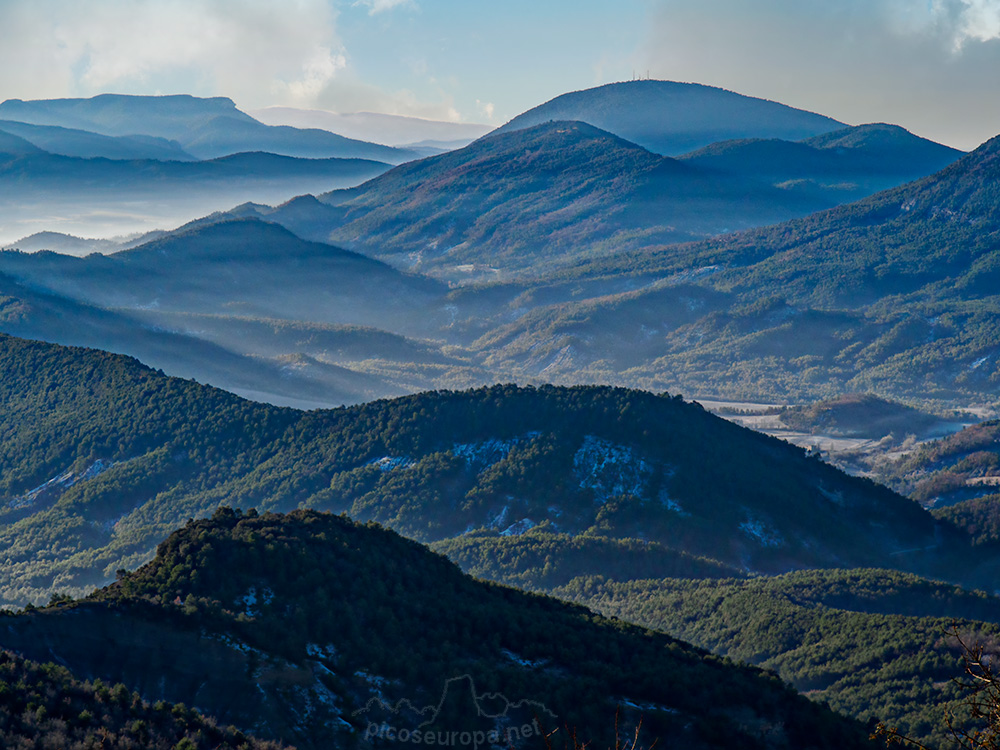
[{"left": 0, "top": 94, "right": 417, "bottom": 247}]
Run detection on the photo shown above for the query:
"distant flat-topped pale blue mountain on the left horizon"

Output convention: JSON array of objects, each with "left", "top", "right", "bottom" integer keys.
[{"left": 0, "top": 94, "right": 412, "bottom": 163}]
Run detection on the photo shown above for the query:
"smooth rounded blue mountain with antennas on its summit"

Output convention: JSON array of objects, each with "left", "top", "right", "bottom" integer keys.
[{"left": 494, "top": 80, "right": 844, "bottom": 156}]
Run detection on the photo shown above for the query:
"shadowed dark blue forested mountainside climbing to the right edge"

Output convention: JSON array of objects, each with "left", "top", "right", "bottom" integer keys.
[{"left": 591, "top": 131, "right": 1000, "bottom": 308}]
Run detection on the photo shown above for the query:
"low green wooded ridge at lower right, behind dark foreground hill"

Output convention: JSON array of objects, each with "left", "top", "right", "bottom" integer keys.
[{"left": 554, "top": 570, "right": 1000, "bottom": 747}]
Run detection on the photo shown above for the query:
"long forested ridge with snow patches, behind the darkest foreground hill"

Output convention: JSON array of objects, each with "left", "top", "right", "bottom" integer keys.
[{"left": 0, "top": 337, "right": 964, "bottom": 604}]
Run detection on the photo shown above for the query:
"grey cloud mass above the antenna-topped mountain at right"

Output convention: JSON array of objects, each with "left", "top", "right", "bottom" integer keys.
[{"left": 640, "top": 0, "right": 1000, "bottom": 148}]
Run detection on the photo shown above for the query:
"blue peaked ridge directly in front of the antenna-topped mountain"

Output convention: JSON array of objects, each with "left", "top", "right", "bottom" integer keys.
[{"left": 219, "top": 121, "right": 960, "bottom": 280}]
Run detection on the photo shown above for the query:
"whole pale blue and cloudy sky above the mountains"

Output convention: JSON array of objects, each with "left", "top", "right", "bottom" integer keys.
[{"left": 0, "top": 0, "right": 1000, "bottom": 149}]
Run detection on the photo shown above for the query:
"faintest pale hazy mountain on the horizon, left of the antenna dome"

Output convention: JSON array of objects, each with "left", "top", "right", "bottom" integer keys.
[{"left": 249, "top": 107, "right": 493, "bottom": 148}]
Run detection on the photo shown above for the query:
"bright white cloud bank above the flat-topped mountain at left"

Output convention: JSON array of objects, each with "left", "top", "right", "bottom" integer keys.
[{"left": 0, "top": 0, "right": 347, "bottom": 106}]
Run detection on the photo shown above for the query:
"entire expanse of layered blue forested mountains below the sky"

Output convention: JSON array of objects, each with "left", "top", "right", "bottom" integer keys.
[{"left": 0, "top": 81, "right": 1000, "bottom": 750}]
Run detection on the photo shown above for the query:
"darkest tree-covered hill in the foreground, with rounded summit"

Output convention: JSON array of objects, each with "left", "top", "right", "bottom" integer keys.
[{"left": 45, "top": 509, "right": 866, "bottom": 748}]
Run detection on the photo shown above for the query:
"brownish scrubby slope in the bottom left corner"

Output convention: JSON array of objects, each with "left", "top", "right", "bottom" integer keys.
[{"left": 0, "top": 651, "right": 281, "bottom": 750}]
